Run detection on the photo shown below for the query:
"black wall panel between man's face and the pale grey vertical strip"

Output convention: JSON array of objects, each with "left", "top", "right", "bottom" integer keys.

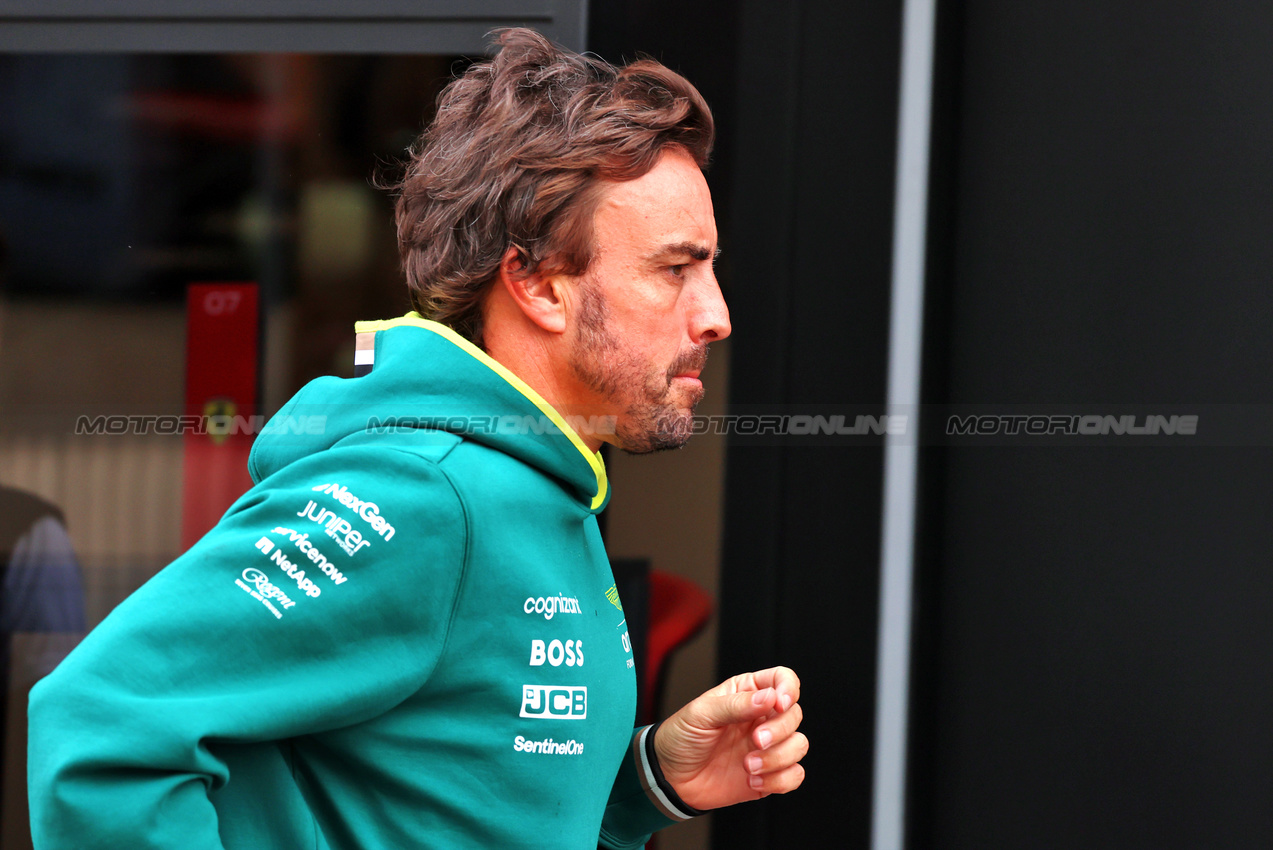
[{"left": 713, "top": 0, "right": 900, "bottom": 849}]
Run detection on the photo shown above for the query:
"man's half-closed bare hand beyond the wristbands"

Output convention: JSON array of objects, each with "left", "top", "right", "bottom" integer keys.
[{"left": 654, "top": 667, "right": 808, "bottom": 809}]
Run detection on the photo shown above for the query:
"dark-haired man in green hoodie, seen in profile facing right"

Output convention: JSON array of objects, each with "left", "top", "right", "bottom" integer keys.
[{"left": 31, "top": 31, "right": 807, "bottom": 850}]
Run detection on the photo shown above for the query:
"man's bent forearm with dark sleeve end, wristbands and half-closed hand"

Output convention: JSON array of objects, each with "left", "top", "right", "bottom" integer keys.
[{"left": 601, "top": 667, "right": 808, "bottom": 850}]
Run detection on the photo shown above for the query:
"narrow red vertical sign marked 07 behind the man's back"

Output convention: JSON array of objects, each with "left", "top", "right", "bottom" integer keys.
[{"left": 181, "top": 284, "right": 264, "bottom": 550}]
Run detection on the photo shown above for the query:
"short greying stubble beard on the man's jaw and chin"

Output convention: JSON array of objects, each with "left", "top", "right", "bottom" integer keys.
[{"left": 570, "top": 282, "right": 708, "bottom": 454}]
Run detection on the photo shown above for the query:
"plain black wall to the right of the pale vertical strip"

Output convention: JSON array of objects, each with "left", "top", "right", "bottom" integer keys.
[{"left": 910, "top": 0, "right": 1273, "bottom": 850}]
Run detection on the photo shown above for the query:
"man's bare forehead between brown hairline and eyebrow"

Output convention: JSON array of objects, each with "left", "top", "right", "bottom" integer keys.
[{"left": 593, "top": 148, "right": 717, "bottom": 253}]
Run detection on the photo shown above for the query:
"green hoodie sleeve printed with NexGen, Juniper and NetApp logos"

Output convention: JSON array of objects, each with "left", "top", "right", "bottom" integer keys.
[{"left": 28, "top": 448, "right": 467, "bottom": 850}]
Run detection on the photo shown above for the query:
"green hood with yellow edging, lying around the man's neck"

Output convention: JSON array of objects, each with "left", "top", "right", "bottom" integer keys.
[{"left": 248, "top": 313, "right": 610, "bottom": 513}]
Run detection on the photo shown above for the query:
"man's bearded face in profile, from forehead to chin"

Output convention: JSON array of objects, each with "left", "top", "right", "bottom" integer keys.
[{"left": 570, "top": 149, "right": 729, "bottom": 454}]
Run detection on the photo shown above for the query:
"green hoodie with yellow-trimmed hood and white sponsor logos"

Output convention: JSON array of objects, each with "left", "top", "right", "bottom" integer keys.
[{"left": 29, "top": 314, "right": 677, "bottom": 850}]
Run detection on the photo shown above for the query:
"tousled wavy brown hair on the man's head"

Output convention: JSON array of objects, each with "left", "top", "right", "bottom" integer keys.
[{"left": 395, "top": 28, "right": 715, "bottom": 345}]
